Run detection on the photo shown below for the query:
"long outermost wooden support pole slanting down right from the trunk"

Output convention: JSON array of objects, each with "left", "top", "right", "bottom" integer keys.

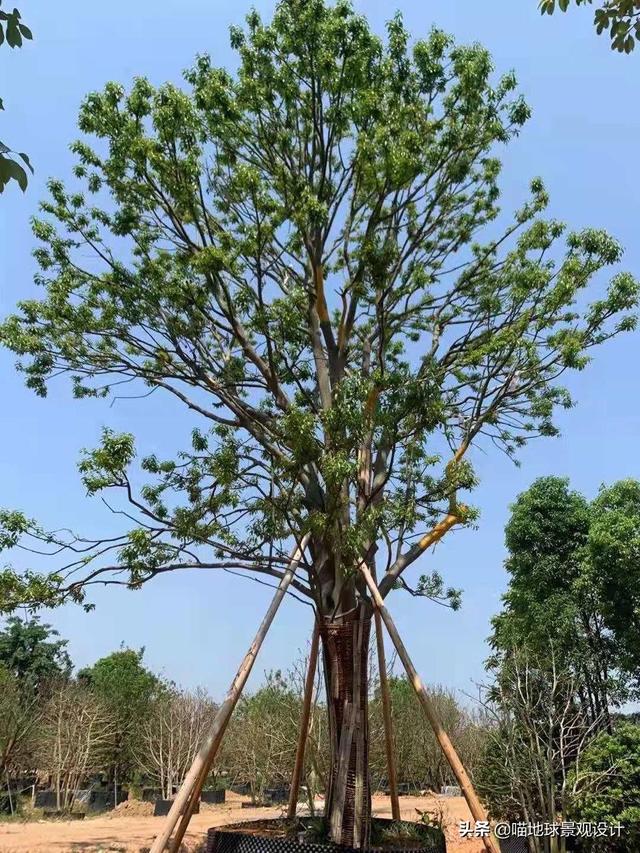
[{"left": 360, "top": 563, "right": 500, "bottom": 853}]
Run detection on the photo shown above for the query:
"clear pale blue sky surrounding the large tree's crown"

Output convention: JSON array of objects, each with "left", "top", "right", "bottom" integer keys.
[{"left": 0, "top": 0, "right": 640, "bottom": 697}]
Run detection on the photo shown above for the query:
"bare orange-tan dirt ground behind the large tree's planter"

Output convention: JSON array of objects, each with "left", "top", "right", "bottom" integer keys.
[{"left": 0, "top": 794, "right": 484, "bottom": 853}]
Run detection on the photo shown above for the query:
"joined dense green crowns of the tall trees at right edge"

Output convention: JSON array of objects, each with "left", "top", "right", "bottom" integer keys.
[{"left": 490, "top": 477, "right": 640, "bottom": 722}]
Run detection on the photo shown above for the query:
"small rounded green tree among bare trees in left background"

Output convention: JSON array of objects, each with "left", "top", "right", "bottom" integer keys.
[{"left": 78, "top": 649, "right": 160, "bottom": 798}]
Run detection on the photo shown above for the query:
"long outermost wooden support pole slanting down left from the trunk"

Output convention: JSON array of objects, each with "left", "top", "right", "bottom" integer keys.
[{"left": 149, "top": 535, "right": 309, "bottom": 853}]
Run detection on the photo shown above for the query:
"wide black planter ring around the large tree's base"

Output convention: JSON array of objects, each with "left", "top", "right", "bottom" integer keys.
[{"left": 206, "top": 818, "right": 447, "bottom": 853}]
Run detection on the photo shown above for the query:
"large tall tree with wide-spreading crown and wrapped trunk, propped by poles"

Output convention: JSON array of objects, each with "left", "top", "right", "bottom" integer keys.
[{"left": 0, "top": 0, "right": 638, "bottom": 846}]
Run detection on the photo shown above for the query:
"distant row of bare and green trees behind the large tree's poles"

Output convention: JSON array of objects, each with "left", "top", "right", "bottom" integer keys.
[{"left": 0, "top": 618, "right": 486, "bottom": 810}]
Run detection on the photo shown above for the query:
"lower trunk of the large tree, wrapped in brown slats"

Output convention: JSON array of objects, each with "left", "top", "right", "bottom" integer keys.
[{"left": 322, "top": 607, "right": 371, "bottom": 848}]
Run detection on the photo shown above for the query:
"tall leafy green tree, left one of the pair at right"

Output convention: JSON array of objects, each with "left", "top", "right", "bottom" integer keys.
[{"left": 490, "top": 477, "right": 625, "bottom": 723}]
